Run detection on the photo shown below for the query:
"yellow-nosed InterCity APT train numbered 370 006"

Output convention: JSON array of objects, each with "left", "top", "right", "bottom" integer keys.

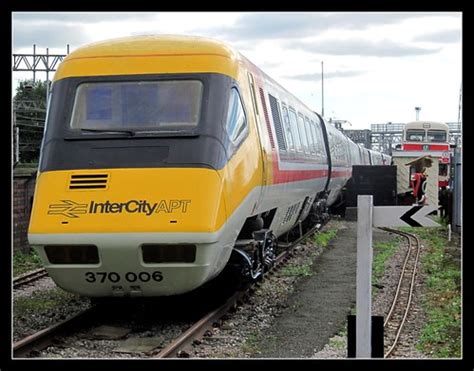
[{"left": 28, "top": 36, "right": 386, "bottom": 297}]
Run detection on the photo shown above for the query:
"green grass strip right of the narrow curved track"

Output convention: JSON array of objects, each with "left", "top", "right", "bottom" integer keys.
[{"left": 403, "top": 227, "right": 461, "bottom": 358}]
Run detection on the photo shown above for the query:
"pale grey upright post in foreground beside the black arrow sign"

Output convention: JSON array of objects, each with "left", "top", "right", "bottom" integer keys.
[{"left": 356, "top": 196, "right": 373, "bottom": 358}]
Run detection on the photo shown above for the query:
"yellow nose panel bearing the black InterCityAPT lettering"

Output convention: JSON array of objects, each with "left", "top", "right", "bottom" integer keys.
[{"left": 29, "top": 168, "right": 226, "bottom": 234}]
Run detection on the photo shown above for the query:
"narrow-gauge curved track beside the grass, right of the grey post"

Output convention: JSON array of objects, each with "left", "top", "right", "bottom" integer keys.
[{"left": 380, "top": 228, "right": 421, "bottom": 358}]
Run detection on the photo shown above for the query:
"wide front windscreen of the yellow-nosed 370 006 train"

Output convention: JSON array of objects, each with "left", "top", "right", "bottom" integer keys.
[{"left": 70, "top": 80, "right": 203, "bottom": 132}]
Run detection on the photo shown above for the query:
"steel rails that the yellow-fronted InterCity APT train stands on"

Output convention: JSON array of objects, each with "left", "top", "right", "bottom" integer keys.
[{"left": 13, "top": 224, "right": 321, "bottom": 358}]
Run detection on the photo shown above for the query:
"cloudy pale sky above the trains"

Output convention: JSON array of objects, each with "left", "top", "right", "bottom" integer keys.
[{"left": 12, "top": 12, "right": 462, "bottom": 129}]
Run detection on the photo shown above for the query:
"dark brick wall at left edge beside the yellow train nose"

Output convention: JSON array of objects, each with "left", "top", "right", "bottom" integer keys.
[{"left": 13, "top": 172, "right": 36, "bottom": 252}]
